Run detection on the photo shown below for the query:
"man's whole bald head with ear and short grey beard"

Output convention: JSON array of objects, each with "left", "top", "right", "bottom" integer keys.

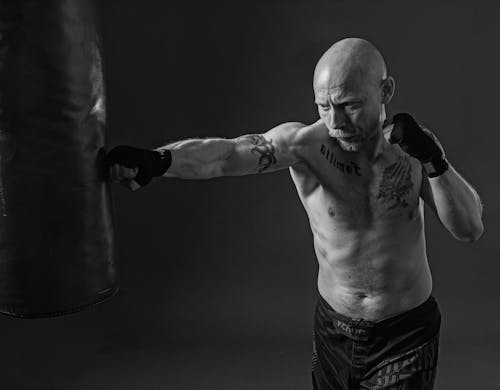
[{"left": 314, "top": 38, "right": 395, "bottom": 151}]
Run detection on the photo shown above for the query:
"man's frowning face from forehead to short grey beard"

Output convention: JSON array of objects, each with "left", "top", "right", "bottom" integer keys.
[{"left": 314, "top": 77, "right": 383, "bottom": 152}]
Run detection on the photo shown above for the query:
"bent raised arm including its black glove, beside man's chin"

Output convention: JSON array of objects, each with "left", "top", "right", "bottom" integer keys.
[{"left": 389, "top": 114, "right": 484, "bottom": 242}]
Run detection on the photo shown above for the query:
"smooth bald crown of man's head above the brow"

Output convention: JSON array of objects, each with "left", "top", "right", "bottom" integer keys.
[{"left": 313, "top": 38, "right": 387, "bottom": 89}]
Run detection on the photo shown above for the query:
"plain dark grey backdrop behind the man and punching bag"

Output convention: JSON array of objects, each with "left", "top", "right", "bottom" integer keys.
[{"left": 0, "top": 0, "right": 500, "bottom": 390}]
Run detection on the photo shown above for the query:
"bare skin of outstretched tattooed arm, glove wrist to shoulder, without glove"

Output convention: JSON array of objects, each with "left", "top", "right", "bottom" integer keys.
[{"left": 157, "top": 123, "right": 304, "bottom": 179}]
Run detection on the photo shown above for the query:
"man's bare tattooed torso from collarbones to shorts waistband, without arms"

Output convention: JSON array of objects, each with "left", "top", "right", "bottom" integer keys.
[{"left": 290, "top": 122, "right": 432, "bottom": 320}]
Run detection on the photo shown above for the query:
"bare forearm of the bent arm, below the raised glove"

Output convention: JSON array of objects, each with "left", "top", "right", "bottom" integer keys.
[{"left": 429, "top": 165, "right": 483, "bottom": 242}]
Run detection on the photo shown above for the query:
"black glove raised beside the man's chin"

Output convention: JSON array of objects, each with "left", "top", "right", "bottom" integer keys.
[{"left": 389, "top": 113, "right": 449, "bottom": 177}]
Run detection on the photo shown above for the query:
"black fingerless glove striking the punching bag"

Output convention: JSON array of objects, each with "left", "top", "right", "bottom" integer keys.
[{"left": 104, "top": 145, "right": 172, "bottom": 186}]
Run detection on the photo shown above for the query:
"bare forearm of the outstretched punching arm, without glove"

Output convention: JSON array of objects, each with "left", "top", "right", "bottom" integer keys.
[{"left": 156, "top": 138, "right": 234, "bottom": 179}]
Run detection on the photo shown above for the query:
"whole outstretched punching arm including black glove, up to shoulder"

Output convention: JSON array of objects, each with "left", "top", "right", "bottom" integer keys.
[{"left": 105, "top": 122, "right": 312, "bottom": 190}]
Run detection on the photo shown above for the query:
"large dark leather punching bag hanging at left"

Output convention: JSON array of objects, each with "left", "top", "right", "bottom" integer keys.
[{"left": 0, "top": 0, "right": 118, "bottom": 318}]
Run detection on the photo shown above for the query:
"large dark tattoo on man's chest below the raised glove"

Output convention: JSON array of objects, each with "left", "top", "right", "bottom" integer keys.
[{"left": 377, "top": 156, "right": 413, "bottom": 210}]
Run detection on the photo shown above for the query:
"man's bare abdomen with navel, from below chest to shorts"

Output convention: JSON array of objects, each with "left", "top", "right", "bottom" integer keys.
[{"left": 314, "top": 212, "right": 432, "bottom": 321}]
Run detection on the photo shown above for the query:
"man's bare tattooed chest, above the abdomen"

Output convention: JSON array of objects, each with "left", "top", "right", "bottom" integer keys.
[{"left": 292, "top": 144, "right": 422, "bottom": 224}]
